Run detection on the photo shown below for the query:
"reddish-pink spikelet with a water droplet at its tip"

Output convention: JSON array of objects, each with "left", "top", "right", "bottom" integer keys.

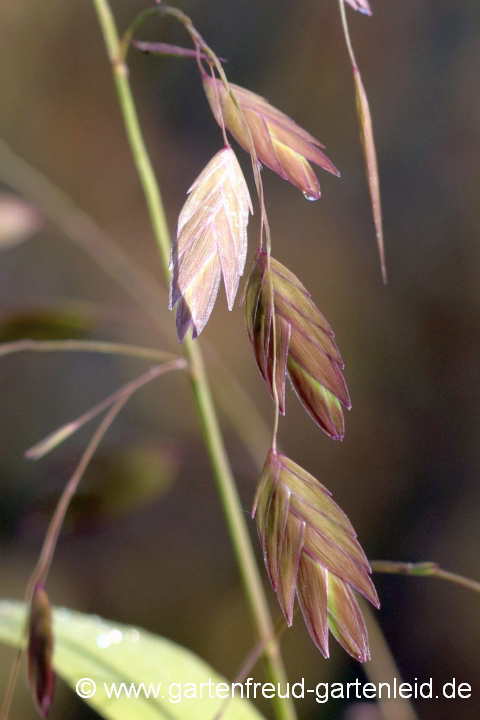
[{"left": 203, "top": 74, "right": 339, "bottom": 200}]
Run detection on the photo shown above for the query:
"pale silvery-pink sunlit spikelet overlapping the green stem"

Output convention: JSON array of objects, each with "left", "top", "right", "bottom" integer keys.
[{"left": 169, "top": 147, "right": 253, "bottom": 342}]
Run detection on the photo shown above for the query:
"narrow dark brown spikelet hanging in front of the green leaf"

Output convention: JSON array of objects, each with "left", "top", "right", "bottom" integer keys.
[{"left": 27, "top": 583, "right": 55, "bottom": 718}]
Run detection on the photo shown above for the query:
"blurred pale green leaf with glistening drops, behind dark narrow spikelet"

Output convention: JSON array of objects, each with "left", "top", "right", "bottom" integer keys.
[{"left": 0, "top": 601, "right": 262, "bottom": 720}]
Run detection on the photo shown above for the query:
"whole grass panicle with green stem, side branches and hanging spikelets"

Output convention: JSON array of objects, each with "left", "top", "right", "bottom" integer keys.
[{"left": 0, "top": 0, "right": 398, "bottom": 720}]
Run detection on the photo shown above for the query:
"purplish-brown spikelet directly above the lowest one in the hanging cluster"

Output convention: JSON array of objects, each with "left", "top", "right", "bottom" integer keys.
[{"left": 244, "top": 251, "right": 351, "bottom": 440}]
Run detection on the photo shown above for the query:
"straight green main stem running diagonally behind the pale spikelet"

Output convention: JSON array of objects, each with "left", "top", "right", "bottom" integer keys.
[{"left": 89, "top": 0, "right": 296, "bottom": 720}]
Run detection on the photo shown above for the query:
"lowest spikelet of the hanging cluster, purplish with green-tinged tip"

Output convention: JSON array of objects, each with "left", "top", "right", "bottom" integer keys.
[{"left": 252, "top": 449, "right": 379, "bottom": 662}]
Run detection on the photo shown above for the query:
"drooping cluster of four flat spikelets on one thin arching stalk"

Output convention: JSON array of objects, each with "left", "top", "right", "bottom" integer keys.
[{"left": 122, "top": 1, "right": 378, "bottom": 661}]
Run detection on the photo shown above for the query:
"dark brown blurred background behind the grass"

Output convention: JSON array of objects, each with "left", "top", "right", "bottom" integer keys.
[{"left": 0, "top": 0, "right": 480, "bottom": 720}]
